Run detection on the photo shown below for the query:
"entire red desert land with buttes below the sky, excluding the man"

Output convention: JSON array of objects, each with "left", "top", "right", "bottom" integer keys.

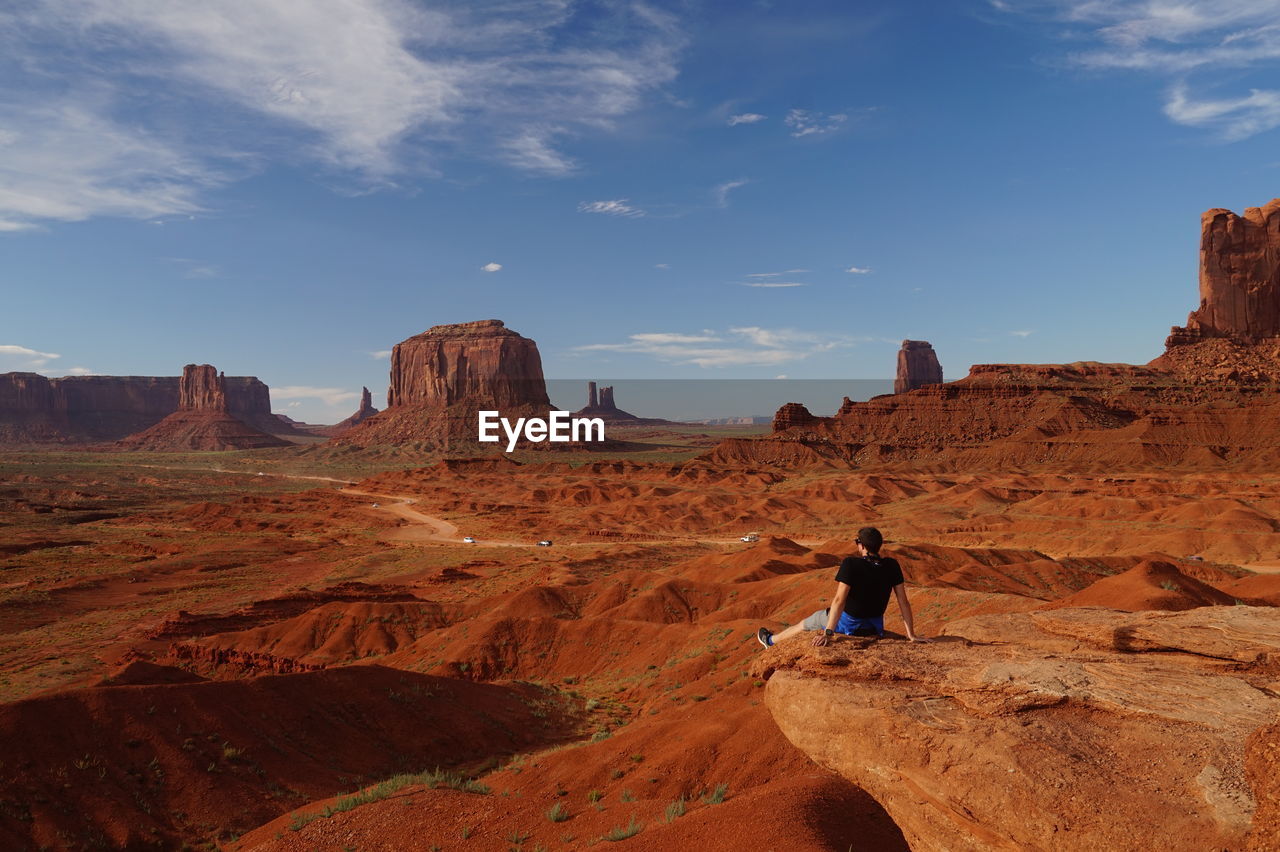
[{"left": 0, "top": 200, "right": 1280, "bottom": 852}]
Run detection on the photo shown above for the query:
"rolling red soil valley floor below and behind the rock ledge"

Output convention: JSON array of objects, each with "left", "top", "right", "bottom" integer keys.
[{"left": 0, "top": 459, "right": 1280, "bottom": 849}]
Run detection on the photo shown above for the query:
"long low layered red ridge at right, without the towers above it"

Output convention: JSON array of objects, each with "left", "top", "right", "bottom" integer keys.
[{"left": 703, "top": 362, "right": 1280, "bottom": 471}]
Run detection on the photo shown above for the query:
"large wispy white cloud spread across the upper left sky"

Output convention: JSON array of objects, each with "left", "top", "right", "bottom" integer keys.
[{"left": 0, "top": 0, "right": 687, "bottom": 230}]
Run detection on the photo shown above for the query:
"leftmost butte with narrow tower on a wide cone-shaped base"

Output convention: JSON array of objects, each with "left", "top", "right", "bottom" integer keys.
[{"left": 116, "top": 363, "right": 289, "bottom": 452}]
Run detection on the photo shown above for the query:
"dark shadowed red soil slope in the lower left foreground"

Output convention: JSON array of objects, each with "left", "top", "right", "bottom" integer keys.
[{"left": 0, "top": 667, "right": 567, "bottom": 848}]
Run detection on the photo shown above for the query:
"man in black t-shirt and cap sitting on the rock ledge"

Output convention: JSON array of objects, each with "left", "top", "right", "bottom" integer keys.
[{"left": 755, "top": 527, "right": 928, "bottom": 647}]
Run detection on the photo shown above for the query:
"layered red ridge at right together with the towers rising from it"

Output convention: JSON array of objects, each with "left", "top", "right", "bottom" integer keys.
[{"left": 705, "top": 200, "right": 1280, "bottom": 469}]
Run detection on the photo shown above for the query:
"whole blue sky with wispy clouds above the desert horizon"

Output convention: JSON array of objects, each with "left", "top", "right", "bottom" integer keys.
[{"left": 0, "top": 0, "right": 1280, "bottom": 422}]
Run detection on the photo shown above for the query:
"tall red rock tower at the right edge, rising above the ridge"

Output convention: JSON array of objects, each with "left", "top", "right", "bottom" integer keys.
[{"left": 1167, "top": 198, "right": 1280, "bottom": 347}]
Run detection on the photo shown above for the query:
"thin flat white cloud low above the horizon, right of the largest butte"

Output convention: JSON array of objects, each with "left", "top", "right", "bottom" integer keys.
[{"left": 576, "top": 326, "right": 856, "bottom": 367}]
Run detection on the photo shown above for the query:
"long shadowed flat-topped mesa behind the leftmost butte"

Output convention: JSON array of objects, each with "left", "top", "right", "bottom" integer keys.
[{"left": 0, "top": 372, "right": 294, "bottom": 444}]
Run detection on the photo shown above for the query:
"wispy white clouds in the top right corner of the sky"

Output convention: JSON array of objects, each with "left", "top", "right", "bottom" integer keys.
[{"left": 992, "top": 0, "right": 1280, "bottom": 141}]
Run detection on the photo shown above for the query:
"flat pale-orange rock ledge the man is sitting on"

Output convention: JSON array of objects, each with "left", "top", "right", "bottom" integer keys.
[{"left": 755, "top": 606, "right": 1280, "bottom": 852}]
